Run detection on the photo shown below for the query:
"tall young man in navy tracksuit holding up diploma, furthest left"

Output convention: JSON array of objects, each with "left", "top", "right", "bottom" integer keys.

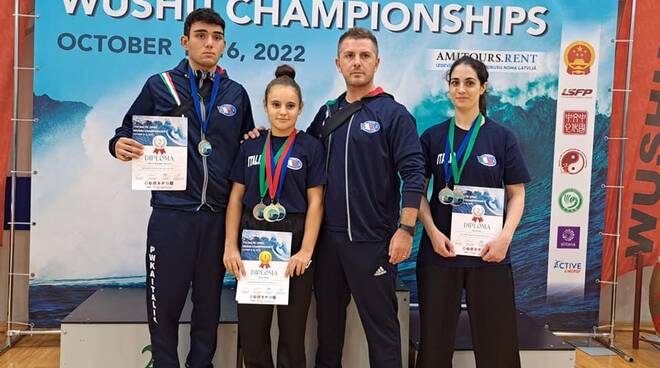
[{"left": 109, "top": 9, "right": 254, "bottom": 368}]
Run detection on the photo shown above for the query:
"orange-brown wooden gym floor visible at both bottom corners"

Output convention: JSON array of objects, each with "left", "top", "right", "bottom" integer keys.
[{"left": 0, "top": 332, "right": 660, "bottom": 368}]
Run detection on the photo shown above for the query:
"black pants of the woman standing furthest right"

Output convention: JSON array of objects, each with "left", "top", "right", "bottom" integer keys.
[{"left": 416, "top": 261, "right": 520, "bottom": 368}]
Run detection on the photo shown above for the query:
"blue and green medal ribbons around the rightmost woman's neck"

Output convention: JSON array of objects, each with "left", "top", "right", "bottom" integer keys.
[{"left": 443, "top": 114, "right": 484, "bottom": 186}]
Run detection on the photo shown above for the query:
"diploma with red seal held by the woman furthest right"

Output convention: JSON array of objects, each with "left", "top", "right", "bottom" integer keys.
[{"left": 450, "top": 185, "right": 504, "bottom": 257}]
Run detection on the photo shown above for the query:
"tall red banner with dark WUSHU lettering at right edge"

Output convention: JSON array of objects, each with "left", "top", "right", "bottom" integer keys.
[{"left": 603, "top": 0, "right": 660, "bottom": 280}]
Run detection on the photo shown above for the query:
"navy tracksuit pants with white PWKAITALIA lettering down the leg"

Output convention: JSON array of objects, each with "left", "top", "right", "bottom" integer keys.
[{"left": 146, "top": 208, "right": 225, "bottom": 368}]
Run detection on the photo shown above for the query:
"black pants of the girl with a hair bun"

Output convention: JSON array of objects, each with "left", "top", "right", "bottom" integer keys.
[{"left": 238, "top": 213, "right": 314, "bottom": 368}]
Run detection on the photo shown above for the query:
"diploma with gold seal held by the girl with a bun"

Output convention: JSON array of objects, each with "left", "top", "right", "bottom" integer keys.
[{"left": 236, "top": 229, "right": 293, "bottom": 305}]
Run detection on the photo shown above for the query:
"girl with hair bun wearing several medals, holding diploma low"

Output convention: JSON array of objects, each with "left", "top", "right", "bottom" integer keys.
[{"left": 224, "top": 65, "right": 325, "bottom": 368}]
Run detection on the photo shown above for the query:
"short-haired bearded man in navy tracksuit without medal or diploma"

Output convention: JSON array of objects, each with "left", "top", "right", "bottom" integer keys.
[{"left": 308, "top": 28, "right": 424, "bottom": 368}]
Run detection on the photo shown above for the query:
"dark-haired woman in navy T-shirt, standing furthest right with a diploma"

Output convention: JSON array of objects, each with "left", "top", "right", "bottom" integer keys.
[{"left": 417, "top": 57, "right": 530, "bottom": 368}]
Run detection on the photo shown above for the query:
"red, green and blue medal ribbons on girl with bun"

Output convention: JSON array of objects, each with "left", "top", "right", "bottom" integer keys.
[{"left": 259, "top": 129, "right": 296, "bottom": 201}]
